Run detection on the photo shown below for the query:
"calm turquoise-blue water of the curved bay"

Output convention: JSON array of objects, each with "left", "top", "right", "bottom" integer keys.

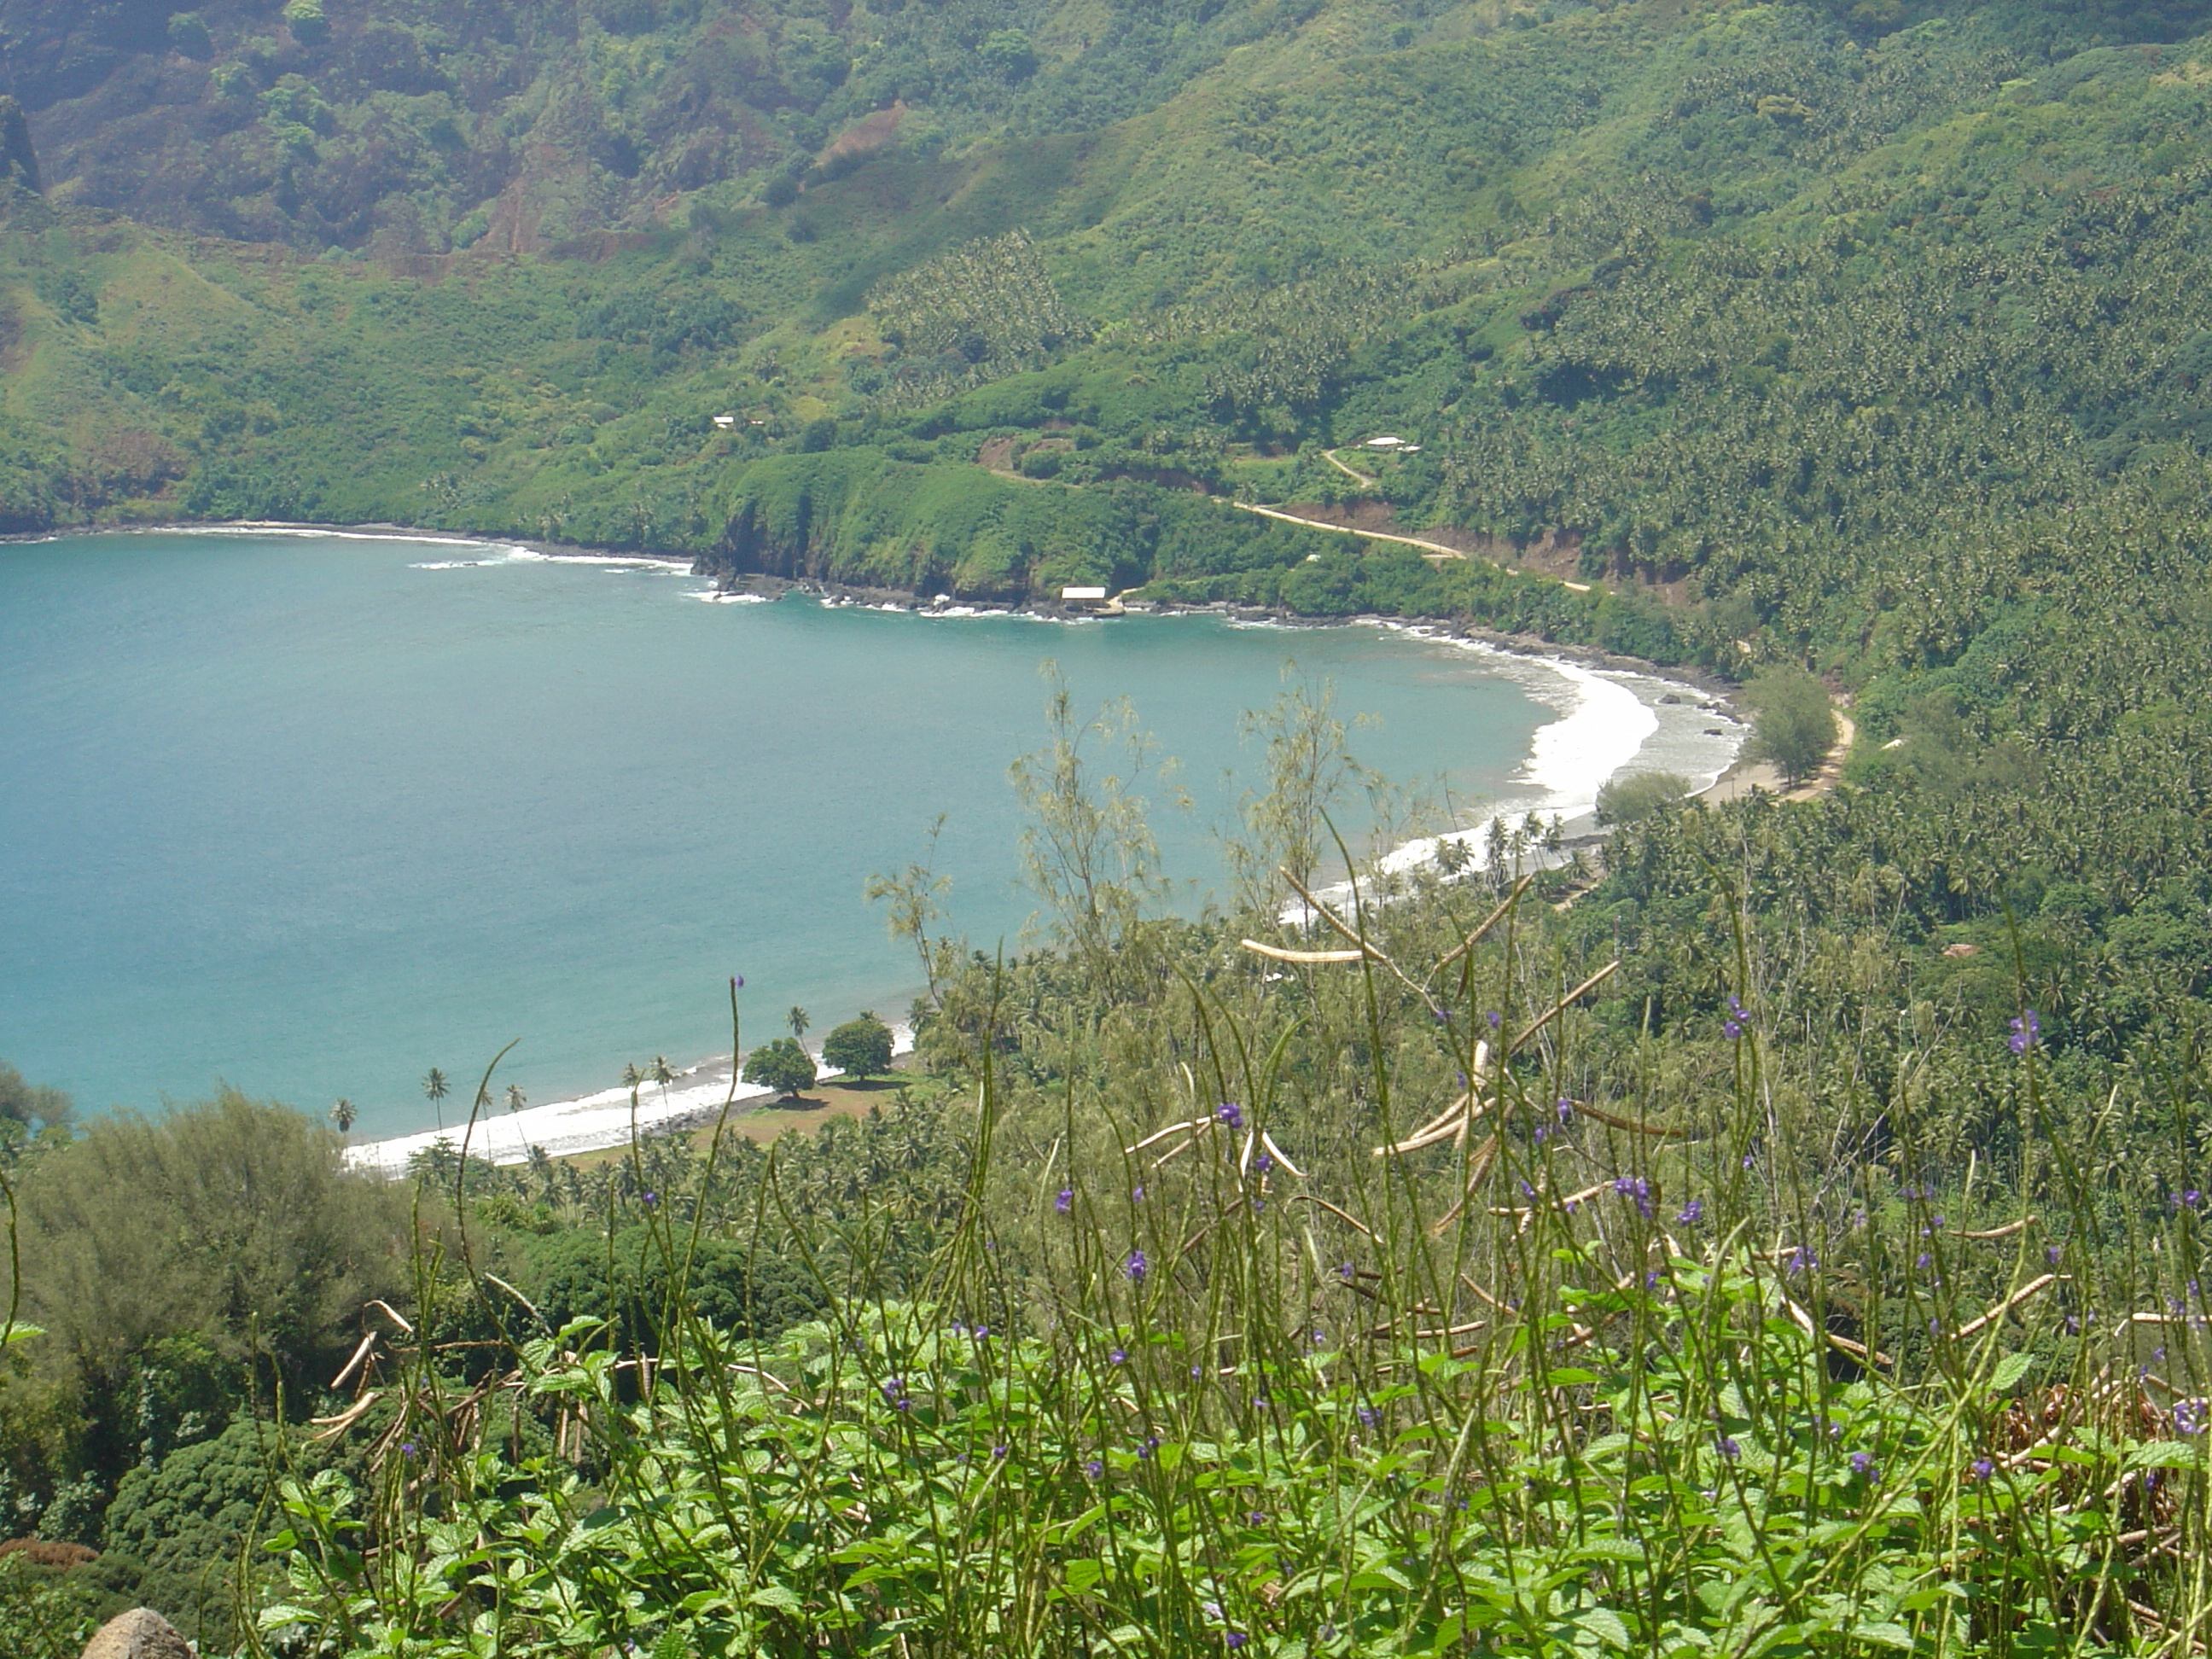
[{"left": 0, "top": 531, "right": 1555, "bottom": 1135}]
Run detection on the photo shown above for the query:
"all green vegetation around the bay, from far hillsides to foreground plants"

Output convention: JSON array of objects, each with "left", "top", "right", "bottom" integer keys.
[{"left": 13, "top": 0, "right": 2212, "bottom": 1656}]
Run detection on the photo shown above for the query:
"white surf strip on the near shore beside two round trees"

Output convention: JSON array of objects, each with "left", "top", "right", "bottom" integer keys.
[{"left": 345, "top": 1024, "right": 913, "bottom": 1177}]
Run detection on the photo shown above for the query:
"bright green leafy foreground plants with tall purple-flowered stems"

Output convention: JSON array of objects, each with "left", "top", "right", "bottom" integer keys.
[{"left": 261, "top": 882, "right": 2212, "bottom": 1656}]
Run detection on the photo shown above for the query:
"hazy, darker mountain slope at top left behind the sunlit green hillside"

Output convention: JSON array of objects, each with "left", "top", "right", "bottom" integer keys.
[{"left": 0, "top": 0, "right": 1318, "bottom": 257}]
